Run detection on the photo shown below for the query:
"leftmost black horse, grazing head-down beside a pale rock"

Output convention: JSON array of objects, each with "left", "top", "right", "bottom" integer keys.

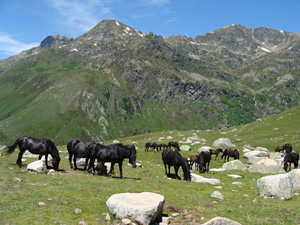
[{"left": 7, "top": 136, "right": 60, "bottom": 170}]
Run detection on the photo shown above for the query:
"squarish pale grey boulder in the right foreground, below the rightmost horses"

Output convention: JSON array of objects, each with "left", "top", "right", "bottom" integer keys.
[{"left": 257, "top": 174, "right": 294, "bottom": 200}]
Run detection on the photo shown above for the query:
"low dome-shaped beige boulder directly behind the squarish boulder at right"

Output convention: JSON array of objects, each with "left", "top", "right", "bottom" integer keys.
[{"left": 248, "top": 158, "right": 285, "bottom": 174}]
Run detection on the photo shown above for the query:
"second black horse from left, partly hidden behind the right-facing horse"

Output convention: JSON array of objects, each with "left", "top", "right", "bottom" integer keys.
[{"left": 67, "top": 140, "right": 94, "bottom": 170}]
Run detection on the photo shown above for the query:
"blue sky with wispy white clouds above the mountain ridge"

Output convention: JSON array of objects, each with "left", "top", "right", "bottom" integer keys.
[{"left": 0, "top": 0, "right": 300, "bottom": 59}]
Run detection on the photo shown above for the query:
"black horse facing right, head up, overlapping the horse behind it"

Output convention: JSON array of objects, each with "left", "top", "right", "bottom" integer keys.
[{"left": 78, "top": 144, "right": 136, "bottom": 178}]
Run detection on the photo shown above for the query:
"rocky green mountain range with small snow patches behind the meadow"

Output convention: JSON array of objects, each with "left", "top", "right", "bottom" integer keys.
[{"left": 0, "top": 20, "right": 300, "bottom": 143}]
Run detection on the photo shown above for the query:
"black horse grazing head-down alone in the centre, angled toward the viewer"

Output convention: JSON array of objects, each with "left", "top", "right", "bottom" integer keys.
[{"left": 162, "top": 149, "right": 191, "bottom": 181}]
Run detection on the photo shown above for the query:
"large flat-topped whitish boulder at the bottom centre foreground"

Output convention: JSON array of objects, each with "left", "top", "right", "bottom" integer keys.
[{"left": 106, "top": 192, "right": 165, "bottom": 224}]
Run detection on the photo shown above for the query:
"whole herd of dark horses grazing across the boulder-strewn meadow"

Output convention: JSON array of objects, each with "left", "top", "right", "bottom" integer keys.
[{"left": 7, "top": 136, "right": 299, "bottom": 180}]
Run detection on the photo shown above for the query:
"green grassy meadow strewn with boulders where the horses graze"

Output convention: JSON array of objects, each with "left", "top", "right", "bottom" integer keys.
[{"left": 0, "top": 107, "right": 300, "bottom": 224}]
